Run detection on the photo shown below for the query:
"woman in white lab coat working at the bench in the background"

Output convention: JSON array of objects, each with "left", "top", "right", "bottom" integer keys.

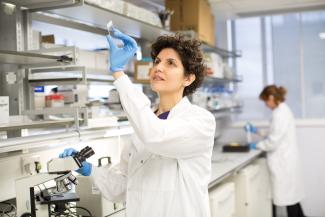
[{"left": 246, "top": 85, "right": 304, "bottom": 217}]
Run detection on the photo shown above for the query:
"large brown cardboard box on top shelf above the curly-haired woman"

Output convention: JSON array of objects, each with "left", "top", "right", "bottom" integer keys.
[{"left": 165, "top": 0, "right": 215, "bottom": 45}]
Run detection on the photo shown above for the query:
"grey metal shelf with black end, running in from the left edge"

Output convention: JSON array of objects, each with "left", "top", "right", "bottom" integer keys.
[{"left": 0, "top": 50, "right": 72, "bottom": 68}]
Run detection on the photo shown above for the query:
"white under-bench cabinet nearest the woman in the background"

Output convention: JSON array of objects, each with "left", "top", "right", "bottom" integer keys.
[{"left": 233, "top": 159, "right": 272, "bottom": 217}]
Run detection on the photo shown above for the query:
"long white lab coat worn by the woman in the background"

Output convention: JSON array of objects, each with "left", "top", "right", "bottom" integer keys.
[{"left": 257, "top": 103, "right": 304, "bottom": 206}]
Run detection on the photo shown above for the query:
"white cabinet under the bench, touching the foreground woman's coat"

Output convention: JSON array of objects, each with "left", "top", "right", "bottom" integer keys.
[{"left": 209, "top": 183, "right": 235, "bottom": 217}]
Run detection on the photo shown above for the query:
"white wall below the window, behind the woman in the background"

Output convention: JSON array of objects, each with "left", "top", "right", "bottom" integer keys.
[{"left": 218, "top": 120, "right": 325, "bottom": 217}]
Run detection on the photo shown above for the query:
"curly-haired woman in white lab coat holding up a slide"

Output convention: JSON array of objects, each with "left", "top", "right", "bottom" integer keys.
[{"left": 61, "top": 29, "right": 215, "bottom": 217}]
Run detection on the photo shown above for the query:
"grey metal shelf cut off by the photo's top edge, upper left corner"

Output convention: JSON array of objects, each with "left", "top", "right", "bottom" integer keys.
[{"left": 4, "top": 0, "right": 83, "bottom": 12}]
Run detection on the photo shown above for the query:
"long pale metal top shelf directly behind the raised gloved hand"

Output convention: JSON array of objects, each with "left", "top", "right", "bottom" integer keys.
[{"left": 32, "top": 2, "right": 174, "bottom": 41}]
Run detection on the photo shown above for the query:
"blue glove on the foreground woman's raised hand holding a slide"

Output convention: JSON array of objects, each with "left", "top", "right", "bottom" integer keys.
[{"left": 106, "top": 28, "right": 138, "bottom": 72}]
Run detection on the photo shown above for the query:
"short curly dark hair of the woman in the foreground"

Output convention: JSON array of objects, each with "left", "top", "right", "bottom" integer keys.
[{"left": 151, "top": 33, "right": 206, "bottom": 96}]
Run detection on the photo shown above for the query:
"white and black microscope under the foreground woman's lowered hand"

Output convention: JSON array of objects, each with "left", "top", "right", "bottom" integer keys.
[{"left": 16, "top": 146, "right": 95, "bottom": 217}]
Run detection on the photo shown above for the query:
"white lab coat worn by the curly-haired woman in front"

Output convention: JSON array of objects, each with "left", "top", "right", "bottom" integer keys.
[{"left": 92, "top": 76, "right": 215, "bottom": 217}]
